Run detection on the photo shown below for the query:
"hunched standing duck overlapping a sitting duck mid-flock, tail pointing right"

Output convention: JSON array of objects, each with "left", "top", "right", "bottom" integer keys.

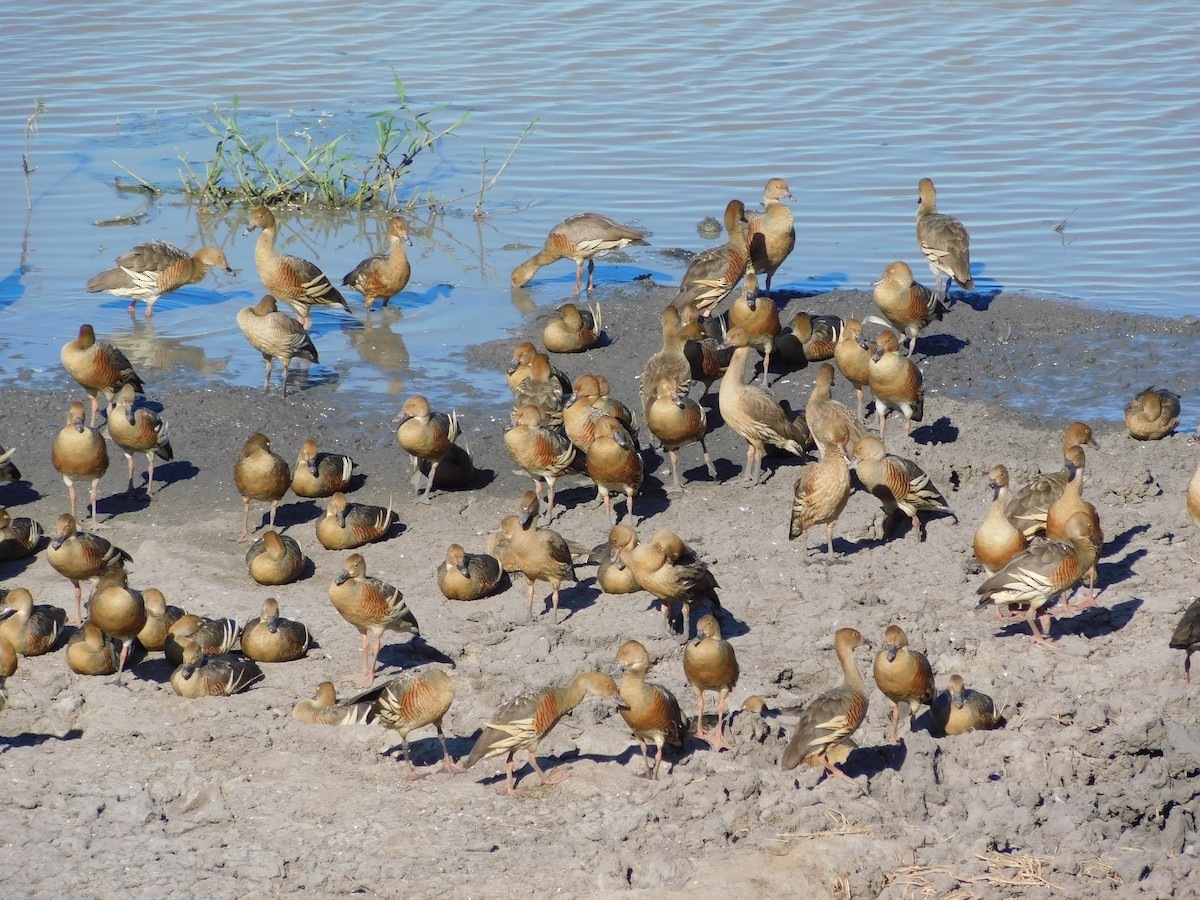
[{"left": 613, "top": 528, "right": 721, "bottom": 640}]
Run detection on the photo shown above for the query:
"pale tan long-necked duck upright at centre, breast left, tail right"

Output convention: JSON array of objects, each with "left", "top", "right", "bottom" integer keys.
[{"left": 716, "top": 328, "right": 805, "bottom": 485}]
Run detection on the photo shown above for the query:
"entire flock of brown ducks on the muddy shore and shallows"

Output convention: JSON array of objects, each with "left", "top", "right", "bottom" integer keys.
[{"left": 0, "top": 178, "right": 1200, "bottom": 792}]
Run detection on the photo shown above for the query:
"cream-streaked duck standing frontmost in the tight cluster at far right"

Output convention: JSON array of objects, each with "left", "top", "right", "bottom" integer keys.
[{"left": 976, "top": 512, "right": 1099, "bottom": 648}]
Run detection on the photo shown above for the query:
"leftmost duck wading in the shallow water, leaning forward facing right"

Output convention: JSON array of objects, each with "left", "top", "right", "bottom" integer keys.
[{"left": 85, "top": 240, "right": 238, "bottom": 319}]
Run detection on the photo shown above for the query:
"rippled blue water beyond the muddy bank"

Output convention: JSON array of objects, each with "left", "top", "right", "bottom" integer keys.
[{"left": 0, "top": 0, "right": 1200, "bottom": 408}]
